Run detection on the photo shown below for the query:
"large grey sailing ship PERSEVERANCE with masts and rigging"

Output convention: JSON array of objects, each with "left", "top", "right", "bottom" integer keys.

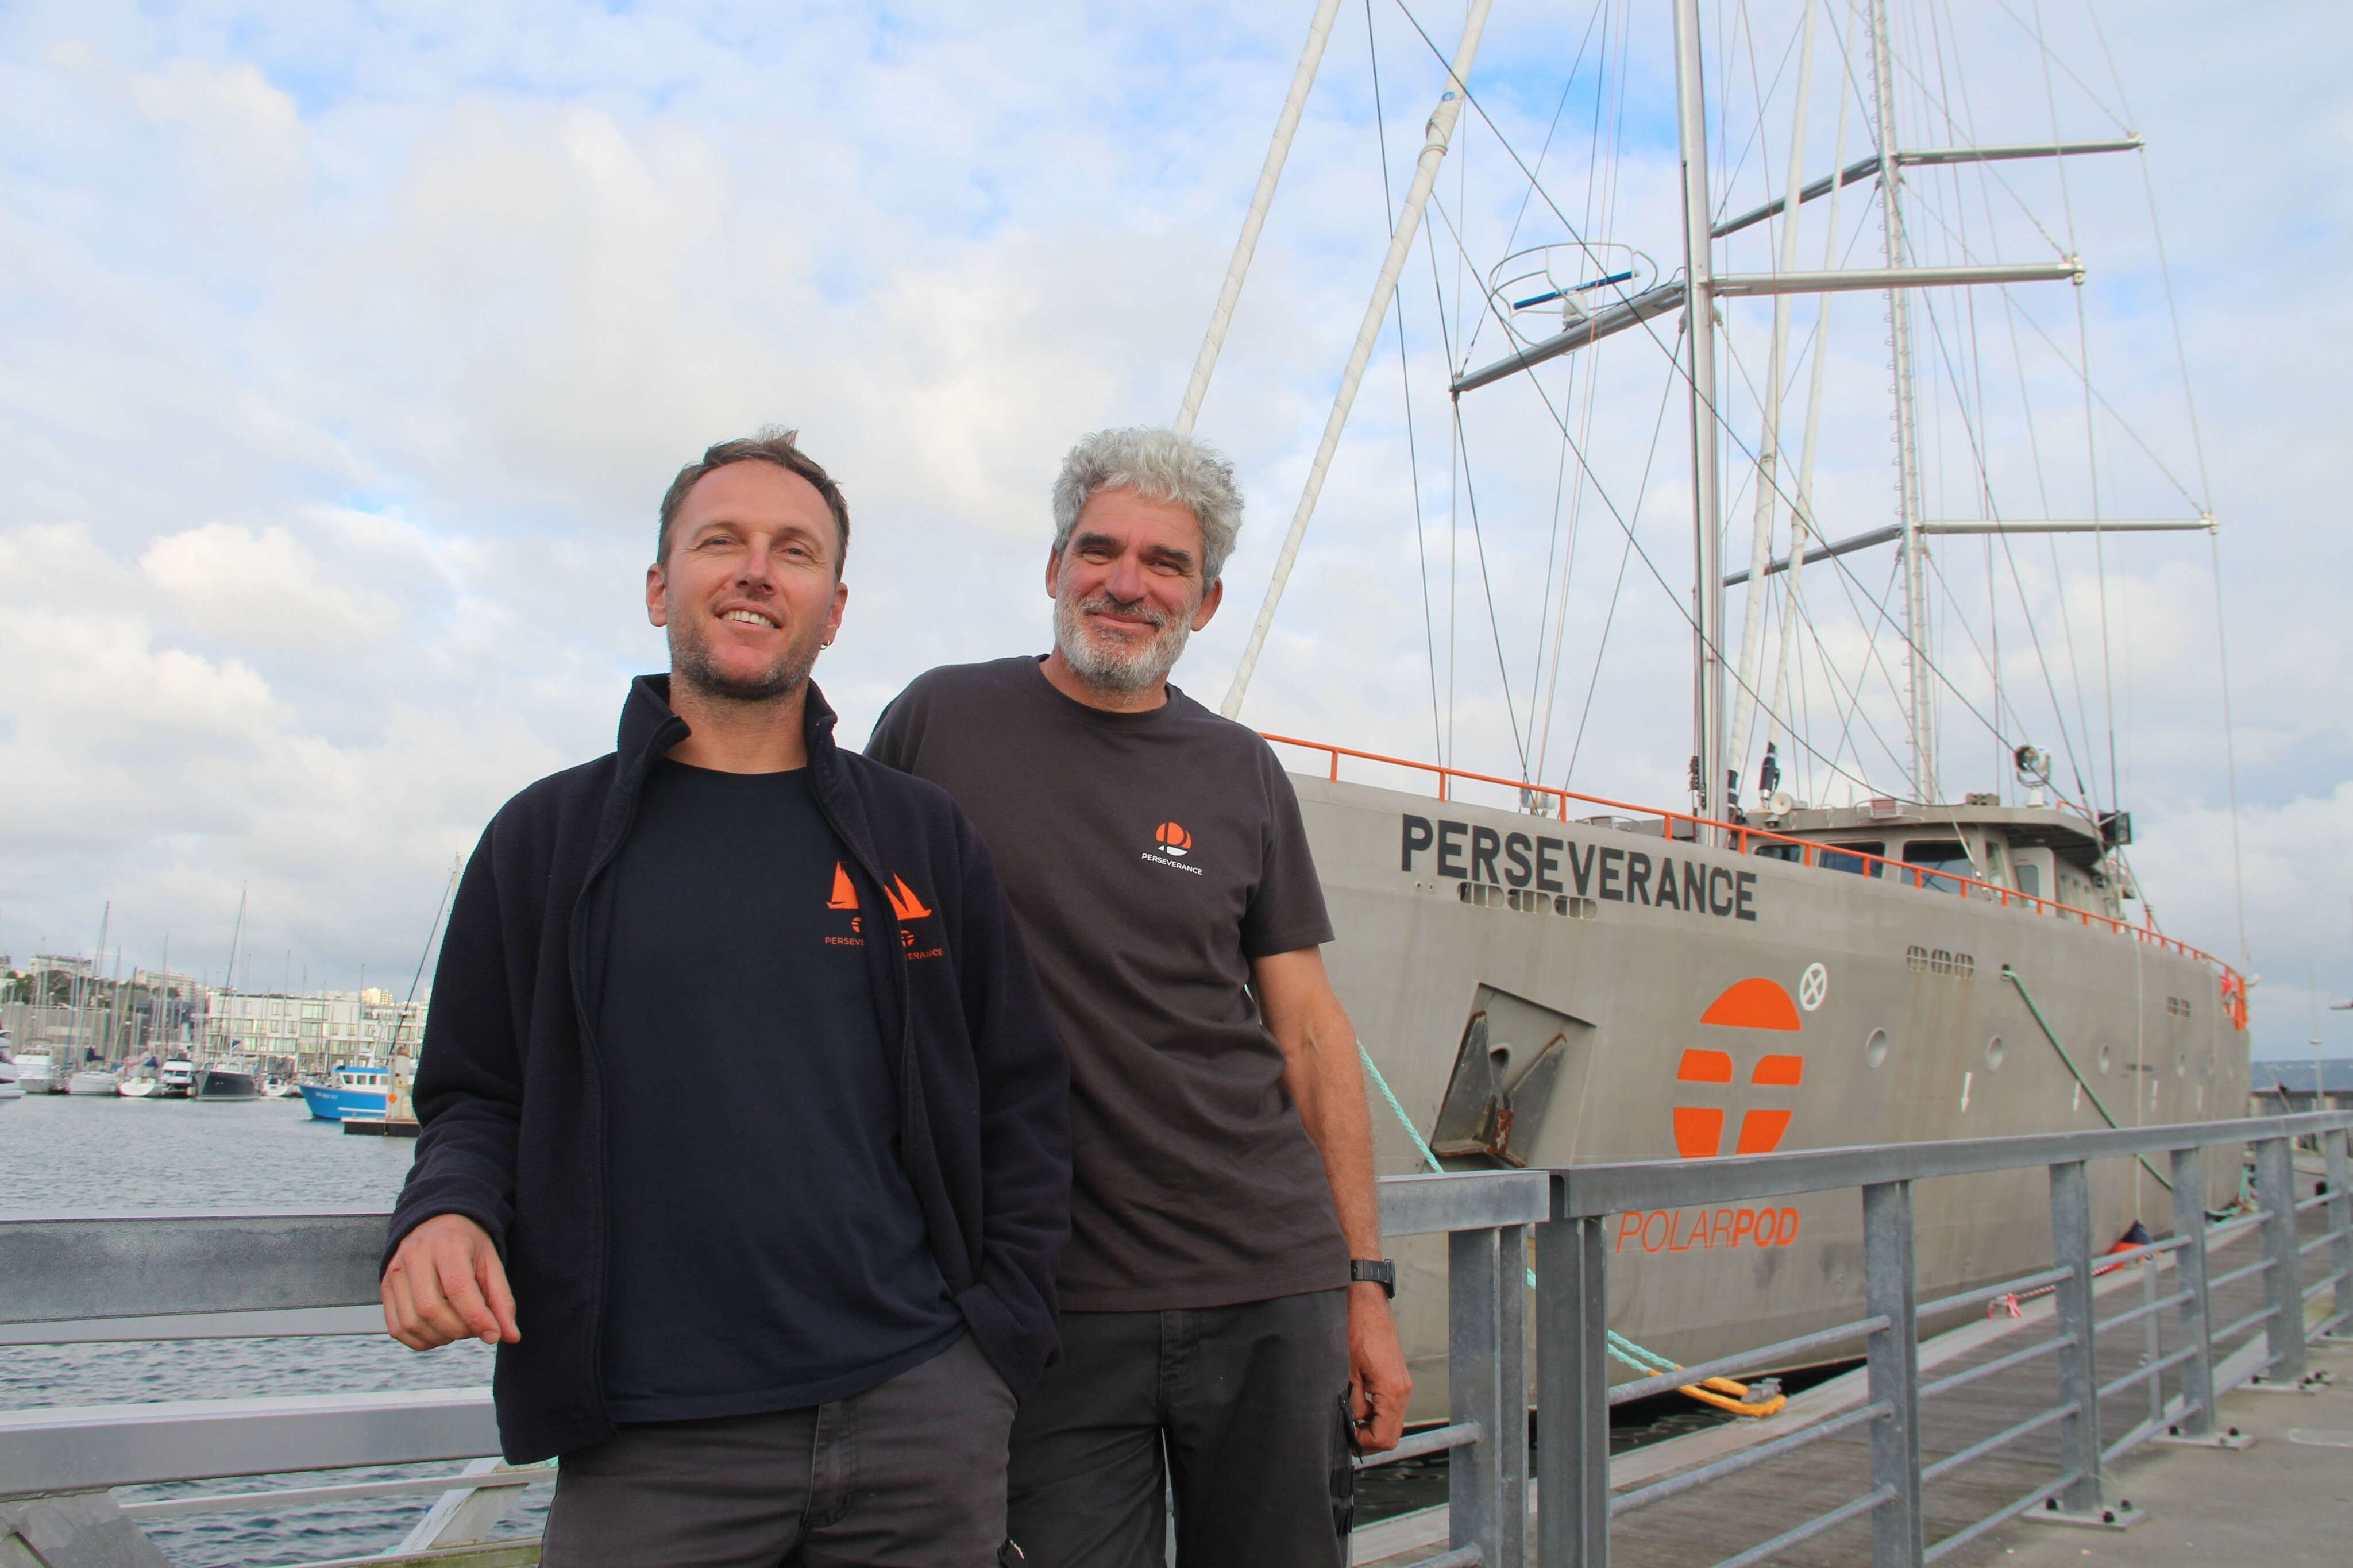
[{"left": 1176, "top": 0, "right": 2247, "bottom": 1415}]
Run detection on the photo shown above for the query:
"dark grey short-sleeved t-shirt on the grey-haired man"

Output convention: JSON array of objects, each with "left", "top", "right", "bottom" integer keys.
[{"left": 866, "top": 658, "right": 1348, "bottom": 1312}]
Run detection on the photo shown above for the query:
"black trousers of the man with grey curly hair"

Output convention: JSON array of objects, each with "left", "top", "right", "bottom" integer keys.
[{"left": 1007, "top": 1291, "right": 1351, "bottom": 1568}]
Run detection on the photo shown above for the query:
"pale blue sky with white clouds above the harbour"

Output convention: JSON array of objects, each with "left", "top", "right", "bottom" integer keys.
[{"left": 0, "top": 0, "right": 2353, "bottom": 1056}]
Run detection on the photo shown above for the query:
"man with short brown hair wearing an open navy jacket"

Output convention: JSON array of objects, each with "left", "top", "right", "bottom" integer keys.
[{"left": 384, "top": 430, "right": 1069, "bottom": 1568}]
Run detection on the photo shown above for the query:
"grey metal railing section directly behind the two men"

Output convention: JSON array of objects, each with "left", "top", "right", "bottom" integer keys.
[{"left": 0, "top": 1171, "right": 1550, "bottom": 1568}]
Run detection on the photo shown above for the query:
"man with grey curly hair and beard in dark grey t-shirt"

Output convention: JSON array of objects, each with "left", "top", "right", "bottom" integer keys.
[{"left": 866, "top": 430, "right": 1412, "bottom": 1568}]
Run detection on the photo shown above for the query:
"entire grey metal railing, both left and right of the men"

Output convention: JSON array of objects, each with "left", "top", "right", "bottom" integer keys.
[{"left": 0, "top": 1112, "right": 2353, "bottom": 1568}]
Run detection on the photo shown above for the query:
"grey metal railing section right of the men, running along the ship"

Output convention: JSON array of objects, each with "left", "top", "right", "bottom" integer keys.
[{"left": 1537, "top": 1112, "right": 2353, "bottom": 1568}]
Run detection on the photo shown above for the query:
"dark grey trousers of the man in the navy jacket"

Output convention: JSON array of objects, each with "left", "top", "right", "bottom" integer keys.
[{"left": 539, "top": 1335, "right": 1014, "bottom": 1568}]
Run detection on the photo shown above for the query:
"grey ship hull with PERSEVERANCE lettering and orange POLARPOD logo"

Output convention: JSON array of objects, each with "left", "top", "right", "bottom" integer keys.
[{"left": 1294, "top": 778, "right": 2247, "bottom": 1418}]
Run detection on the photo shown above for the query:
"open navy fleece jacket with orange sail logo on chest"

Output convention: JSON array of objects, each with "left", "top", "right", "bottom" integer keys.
[{"left": 386, "top": 675, "right": 1071, "bottom": 1465}]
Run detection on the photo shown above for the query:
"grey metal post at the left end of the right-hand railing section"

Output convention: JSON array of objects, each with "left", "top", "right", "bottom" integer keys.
[{"left": 1537, "top": 1212, "right": 1610, "bottom": 1568}]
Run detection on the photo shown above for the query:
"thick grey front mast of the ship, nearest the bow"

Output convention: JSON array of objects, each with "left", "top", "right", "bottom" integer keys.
[{"left": 1675, "top": 0, "right": 1727, "bottom": 841}]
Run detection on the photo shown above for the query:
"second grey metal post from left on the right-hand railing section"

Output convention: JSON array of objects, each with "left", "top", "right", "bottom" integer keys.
[{"left": 1864, "top": 1183, "right": 1922, "bottom": 1568}]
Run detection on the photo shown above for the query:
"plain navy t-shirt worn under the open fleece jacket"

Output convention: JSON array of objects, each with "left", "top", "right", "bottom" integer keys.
[{"left": 591, "top": 762, "right": 962, "bottom": 1420}]
